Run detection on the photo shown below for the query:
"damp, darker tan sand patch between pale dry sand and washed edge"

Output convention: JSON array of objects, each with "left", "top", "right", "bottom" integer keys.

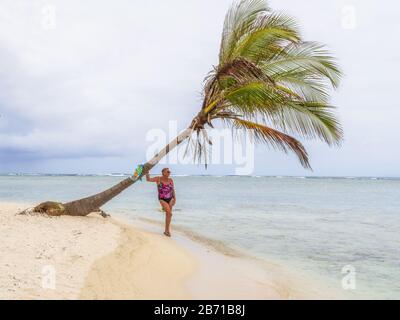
[{"left": 79, "top": 219, "right": 197, "bottom": 299}]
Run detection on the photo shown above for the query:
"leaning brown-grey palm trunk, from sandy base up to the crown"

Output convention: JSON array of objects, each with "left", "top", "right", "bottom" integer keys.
[{"left": 20, "top": 124, "right": 199, "bottom": 216}]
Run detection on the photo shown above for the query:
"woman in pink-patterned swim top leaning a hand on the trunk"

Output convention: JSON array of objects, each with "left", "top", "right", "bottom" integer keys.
[{"left": 146, "top": 168, "right": 176, "bottom": 237}]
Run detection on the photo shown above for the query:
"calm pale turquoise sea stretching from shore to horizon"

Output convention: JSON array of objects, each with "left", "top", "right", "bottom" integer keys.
[{"left": 0, "top": 175, "right": 400, "bottom": 299}]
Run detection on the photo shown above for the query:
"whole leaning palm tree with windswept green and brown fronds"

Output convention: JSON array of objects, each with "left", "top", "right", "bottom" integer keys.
[{"left": 23, "top": 0, "right": 342, "bottom": 216}]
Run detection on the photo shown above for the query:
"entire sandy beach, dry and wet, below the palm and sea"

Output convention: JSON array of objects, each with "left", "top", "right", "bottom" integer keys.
[{"left": 0, "top": 203, "right": 340, "bottom": 299}]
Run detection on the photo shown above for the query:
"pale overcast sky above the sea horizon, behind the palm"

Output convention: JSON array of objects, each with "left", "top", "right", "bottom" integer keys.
[{"left": 0, "top": 0, "right": 400, "bottom": 177}]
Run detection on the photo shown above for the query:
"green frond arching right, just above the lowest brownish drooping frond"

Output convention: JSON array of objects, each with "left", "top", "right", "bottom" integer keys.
[{"left": 214, "top": 81, "right": 343, "bottom": 145}]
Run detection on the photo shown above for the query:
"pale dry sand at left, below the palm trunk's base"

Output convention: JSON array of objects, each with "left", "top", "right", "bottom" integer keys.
[{"left": 0, "top": 203, "right": 121, "bottom": 299}]
